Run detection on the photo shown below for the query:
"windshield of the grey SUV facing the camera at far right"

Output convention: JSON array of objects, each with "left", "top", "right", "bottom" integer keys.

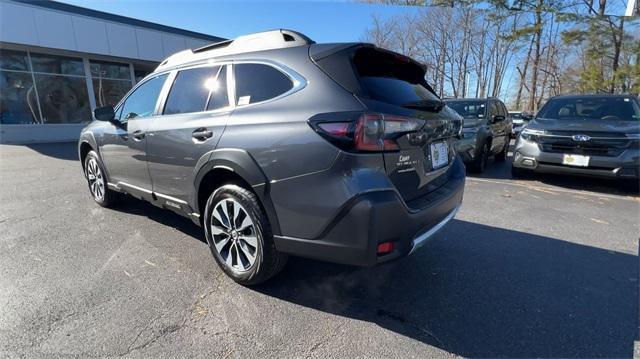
[{"left": 536, "top": 97, "right": 640, "bottom": 121}]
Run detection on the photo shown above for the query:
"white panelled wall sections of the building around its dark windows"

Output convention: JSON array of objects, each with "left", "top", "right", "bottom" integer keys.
[{"left": 0, "top": 0, "right": 218, "bottom": 143}]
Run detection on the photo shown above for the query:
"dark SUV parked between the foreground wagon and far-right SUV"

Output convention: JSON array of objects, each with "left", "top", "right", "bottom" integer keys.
[{"left": 446, "top": 98, "right": 513, "bottom": 173}]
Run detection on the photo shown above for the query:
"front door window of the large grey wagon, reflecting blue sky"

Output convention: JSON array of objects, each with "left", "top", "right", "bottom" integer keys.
[{"left": 119, "top": 74, "right": 167, "bottom": 122}]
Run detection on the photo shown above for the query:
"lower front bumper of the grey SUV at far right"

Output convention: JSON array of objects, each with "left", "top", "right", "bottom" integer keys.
[{"left": 513, "top": 138, "right": 640, "bottom": 179}]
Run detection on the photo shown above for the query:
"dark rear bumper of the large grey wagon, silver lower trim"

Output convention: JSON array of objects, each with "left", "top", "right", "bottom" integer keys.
[{"left": 274, "top": 158, "right": 465, "bottom": 266}]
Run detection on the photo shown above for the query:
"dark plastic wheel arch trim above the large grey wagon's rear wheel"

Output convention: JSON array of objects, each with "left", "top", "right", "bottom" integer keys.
[{"left": 193, "top": 149, "right": 280, "bottom": 235}]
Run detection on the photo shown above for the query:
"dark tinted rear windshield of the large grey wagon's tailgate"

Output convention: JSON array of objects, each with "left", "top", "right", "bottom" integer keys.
[{"left": 353, "top": 48, "right": 439, "bottom": 106}]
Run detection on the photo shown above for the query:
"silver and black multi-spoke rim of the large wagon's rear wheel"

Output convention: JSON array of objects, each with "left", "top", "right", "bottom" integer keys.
[{"left": 210, "top": 198, "right": 258, "bottom": 272}]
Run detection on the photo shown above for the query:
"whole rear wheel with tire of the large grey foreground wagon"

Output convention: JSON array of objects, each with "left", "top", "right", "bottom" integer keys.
[{"left": 203, "top": 184, "right": 287, "bottom": 285}]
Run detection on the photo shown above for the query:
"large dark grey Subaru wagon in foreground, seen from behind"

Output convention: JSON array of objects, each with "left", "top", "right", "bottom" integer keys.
[{"left": 79, "top": 30, "right": 465, "bottom": 284}]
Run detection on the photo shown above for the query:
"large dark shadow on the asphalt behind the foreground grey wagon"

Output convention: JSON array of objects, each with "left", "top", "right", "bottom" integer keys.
[{"left": 255, "top": 220, "right": 638, "bottom": 357}]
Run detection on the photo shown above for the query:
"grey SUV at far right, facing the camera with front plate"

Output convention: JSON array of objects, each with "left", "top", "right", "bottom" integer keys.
[{"left": 512, "top": 95, "right": 640, "bottom": 186}]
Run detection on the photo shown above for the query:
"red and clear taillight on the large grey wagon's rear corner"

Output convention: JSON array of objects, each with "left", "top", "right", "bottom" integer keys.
[{"left": 309, "top": 113, "right": 424, "bottom": 152}]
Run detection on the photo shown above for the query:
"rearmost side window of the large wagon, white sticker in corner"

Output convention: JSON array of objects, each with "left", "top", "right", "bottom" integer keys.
[{"left": 234, "top": 64, "right": 293, "bottom": 106}]
